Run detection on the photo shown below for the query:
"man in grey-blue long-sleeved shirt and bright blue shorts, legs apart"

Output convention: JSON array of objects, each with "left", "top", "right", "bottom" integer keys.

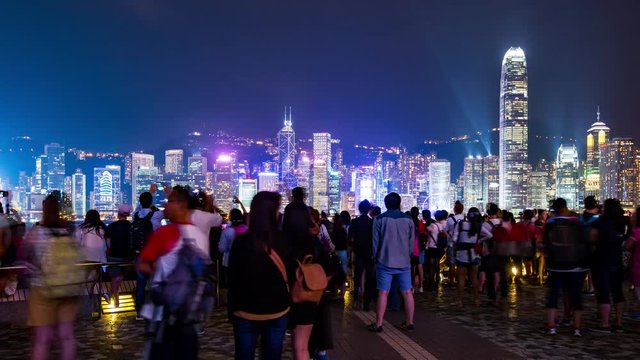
[{"left": 367, "top": 192, "right": 415, "bottom": 332}]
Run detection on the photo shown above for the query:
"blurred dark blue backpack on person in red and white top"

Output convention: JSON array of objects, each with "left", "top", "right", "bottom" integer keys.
[{"left": 150, "top": 239, "right": 215, "bottom": 325}]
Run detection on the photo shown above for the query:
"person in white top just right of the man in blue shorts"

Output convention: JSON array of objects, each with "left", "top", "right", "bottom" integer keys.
[{"left": 427, "top": 210, "right": 449, "bottom": 291}]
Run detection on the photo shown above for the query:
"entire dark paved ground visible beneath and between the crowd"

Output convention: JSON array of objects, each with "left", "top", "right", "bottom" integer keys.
[{"left": 0, "top": 286, "right": 640, "bottom": 360}]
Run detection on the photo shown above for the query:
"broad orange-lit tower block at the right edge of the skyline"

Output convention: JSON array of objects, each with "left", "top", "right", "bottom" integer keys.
[{"left": 600, "top": 138, "right": 638, "bottom": 210}]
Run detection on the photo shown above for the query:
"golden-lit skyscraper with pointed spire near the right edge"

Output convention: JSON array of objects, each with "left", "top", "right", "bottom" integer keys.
[{"left": 585, "top": 107, "right": 609, "bottom": 200}]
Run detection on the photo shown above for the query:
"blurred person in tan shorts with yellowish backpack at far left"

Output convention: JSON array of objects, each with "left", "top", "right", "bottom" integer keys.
[{"left": 22, "top": 195, "right": 81, "bottom": 360}]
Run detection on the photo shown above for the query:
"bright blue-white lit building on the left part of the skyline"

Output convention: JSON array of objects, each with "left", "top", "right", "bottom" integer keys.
[{"left": 91, "top": 165, "right": 122, "bottom": 219}]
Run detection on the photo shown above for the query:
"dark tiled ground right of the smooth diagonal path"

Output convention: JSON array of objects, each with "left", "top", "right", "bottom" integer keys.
[{"left": 416, "top": 286, "right": 640, "bottom": 359}]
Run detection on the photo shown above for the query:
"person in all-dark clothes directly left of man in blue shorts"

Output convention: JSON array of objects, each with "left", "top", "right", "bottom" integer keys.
[{"left": 349, "top": 200, "right": 376, "bottom": 311}]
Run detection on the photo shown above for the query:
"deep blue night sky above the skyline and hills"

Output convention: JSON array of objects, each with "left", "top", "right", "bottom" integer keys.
[{"left": 0, "top": 0, "right": 640, "bottom": 151}]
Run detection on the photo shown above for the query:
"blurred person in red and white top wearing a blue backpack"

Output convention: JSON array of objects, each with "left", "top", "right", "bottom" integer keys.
[{"left": 137, "top": 186, "right": 213, "bottom": 359}]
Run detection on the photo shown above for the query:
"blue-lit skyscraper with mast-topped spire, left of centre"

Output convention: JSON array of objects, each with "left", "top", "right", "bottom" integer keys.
[{"left": 278, "top": 107, "right": 296, "bottom": 190}]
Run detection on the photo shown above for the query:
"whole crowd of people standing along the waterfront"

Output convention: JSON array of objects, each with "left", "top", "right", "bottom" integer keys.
[{"left": 0, "top": 186, "right": 640, "bottom": 360}]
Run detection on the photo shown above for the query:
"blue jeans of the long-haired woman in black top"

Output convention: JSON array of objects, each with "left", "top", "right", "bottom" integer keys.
[{"left": 233, "top": 315, "right": 289, "bottom": 360}]
